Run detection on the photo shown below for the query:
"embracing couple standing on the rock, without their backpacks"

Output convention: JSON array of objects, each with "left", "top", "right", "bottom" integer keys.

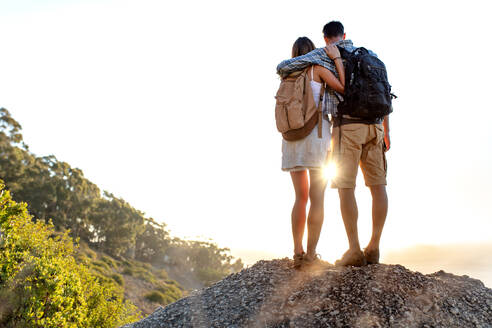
[{"left": 277, "top": 21, "right": 390, "bottom": 268}]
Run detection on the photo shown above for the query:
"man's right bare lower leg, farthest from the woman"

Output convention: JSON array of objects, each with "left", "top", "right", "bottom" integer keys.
[{"left": 366, "top": 185, "right": 388, "bottom": 252}]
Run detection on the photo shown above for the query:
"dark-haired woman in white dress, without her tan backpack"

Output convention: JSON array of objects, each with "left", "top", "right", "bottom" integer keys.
[{"left": 282, "top": 37, "right": 345, "bottom": 268}]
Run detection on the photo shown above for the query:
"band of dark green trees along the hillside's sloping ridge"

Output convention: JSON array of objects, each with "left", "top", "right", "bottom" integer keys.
[{"left": 0, "top": 108, "right": 243, "bottom": 285}]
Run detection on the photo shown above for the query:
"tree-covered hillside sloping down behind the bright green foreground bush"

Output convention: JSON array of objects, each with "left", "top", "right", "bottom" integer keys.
[{"left": 0, "top": 108, "right": 243, "bottom": 319}]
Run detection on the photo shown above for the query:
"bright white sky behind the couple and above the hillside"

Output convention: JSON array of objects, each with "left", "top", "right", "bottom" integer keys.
[{"left": 0, "top": 0, "right": 492, "bottom": 270}]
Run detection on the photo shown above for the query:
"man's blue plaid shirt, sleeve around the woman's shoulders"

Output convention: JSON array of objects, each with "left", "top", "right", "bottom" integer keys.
[{"left": 277, "top": 40, "right": 355, "bottom": 116}]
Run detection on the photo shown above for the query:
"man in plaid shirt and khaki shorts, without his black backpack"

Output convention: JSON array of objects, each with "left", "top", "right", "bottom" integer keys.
[{"left": 277, "top": 21, "right": 390, "bottom": 266}]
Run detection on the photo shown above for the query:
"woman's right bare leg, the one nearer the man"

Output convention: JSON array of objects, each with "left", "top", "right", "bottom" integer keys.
[{"left": 307, "top": 170, "right": 326, "bottom": 257}]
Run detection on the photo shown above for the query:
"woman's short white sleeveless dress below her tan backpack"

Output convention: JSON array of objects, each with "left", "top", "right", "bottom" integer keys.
[{"left": 282, "top": 66, "right": 331, "bottom": 171}]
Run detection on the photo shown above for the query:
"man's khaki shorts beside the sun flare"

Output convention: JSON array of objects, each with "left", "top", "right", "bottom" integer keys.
[{"left": 331, "top": 123, "right": 387, "bottom": 188}]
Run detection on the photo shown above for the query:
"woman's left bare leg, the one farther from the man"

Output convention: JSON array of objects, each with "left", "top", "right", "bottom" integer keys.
[{"left": 290, "top": 170, "right": 309, "bottom": 254}]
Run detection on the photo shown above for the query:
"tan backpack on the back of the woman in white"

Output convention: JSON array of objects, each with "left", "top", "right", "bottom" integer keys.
[{"left": 275, "top": 67, "right": 325, "bottom": 141}]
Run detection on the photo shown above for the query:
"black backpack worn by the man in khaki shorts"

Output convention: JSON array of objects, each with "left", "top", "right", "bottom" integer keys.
[{"left": 337, "top": 47, "right": 396, "bottom": 120}]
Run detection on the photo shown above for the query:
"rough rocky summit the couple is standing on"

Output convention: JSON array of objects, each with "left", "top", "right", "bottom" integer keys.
[{"left": 124, "top": 259, "right": 492, "bottom": 328}]
